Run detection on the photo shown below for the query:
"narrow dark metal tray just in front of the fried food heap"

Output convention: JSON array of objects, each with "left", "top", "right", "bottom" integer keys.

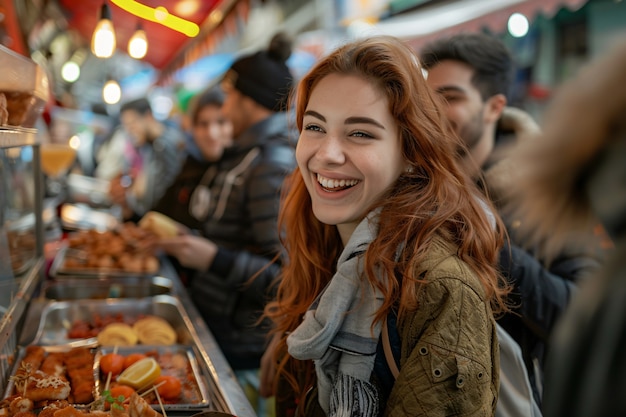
[{"left": 42, "top": 276, "right": 174, "bottom": 301}]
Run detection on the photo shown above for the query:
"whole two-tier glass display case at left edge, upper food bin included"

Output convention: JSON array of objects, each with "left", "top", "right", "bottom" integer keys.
[{"left": 0, "top": 45, "right": 48, "bottom": 394}]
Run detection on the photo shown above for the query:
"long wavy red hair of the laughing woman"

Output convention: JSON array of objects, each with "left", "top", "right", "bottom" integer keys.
[{"left": 265, "top": 37, "right": 507, "bottom": 404}]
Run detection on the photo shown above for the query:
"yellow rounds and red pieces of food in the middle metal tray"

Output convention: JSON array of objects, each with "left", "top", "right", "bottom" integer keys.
[{"left": 74, "top": 314, "right": 178, "bottom": 346}]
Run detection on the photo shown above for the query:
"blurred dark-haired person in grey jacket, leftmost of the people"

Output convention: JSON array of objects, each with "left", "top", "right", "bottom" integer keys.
[{"left": 110, "top": 98, "right": 185, "bottom": 220}]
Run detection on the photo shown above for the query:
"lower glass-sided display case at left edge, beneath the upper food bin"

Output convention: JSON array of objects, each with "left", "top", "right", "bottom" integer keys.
[{"left": 0, "top": 127, "right": 43, "bottom": 394}]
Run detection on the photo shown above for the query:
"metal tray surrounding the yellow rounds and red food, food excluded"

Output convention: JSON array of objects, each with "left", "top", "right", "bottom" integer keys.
[{"left": 30, "top": 295, "right": 195, "bottom": 345}]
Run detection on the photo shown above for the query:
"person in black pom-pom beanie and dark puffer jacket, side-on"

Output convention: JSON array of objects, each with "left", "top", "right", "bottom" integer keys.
[{"left": 154, "top": 34, "right": 297, "bottom": 416}]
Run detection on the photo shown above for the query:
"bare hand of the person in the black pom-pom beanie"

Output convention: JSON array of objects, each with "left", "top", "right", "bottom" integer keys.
[{"left": 157, "top": 234, "right": 217, "bottom": 271}]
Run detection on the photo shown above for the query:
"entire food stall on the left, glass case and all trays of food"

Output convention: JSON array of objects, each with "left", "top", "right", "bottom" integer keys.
[{"left": 0, "top": 45, "right": 255, "bottom": 417}]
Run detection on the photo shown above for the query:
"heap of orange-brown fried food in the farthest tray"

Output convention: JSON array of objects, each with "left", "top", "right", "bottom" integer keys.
[{"left": 61, "top": 222, "right": 159, "bottom": 274}]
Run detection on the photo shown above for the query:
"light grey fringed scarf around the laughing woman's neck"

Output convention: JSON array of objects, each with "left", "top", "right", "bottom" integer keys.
[{"left": 287, "top": 211, "right": 384, "bottom": 417}]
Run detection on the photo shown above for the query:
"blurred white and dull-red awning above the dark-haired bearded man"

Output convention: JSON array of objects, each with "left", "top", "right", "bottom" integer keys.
[{"left": 378, "top": 0, "right": 588, "bottom": 49}]
